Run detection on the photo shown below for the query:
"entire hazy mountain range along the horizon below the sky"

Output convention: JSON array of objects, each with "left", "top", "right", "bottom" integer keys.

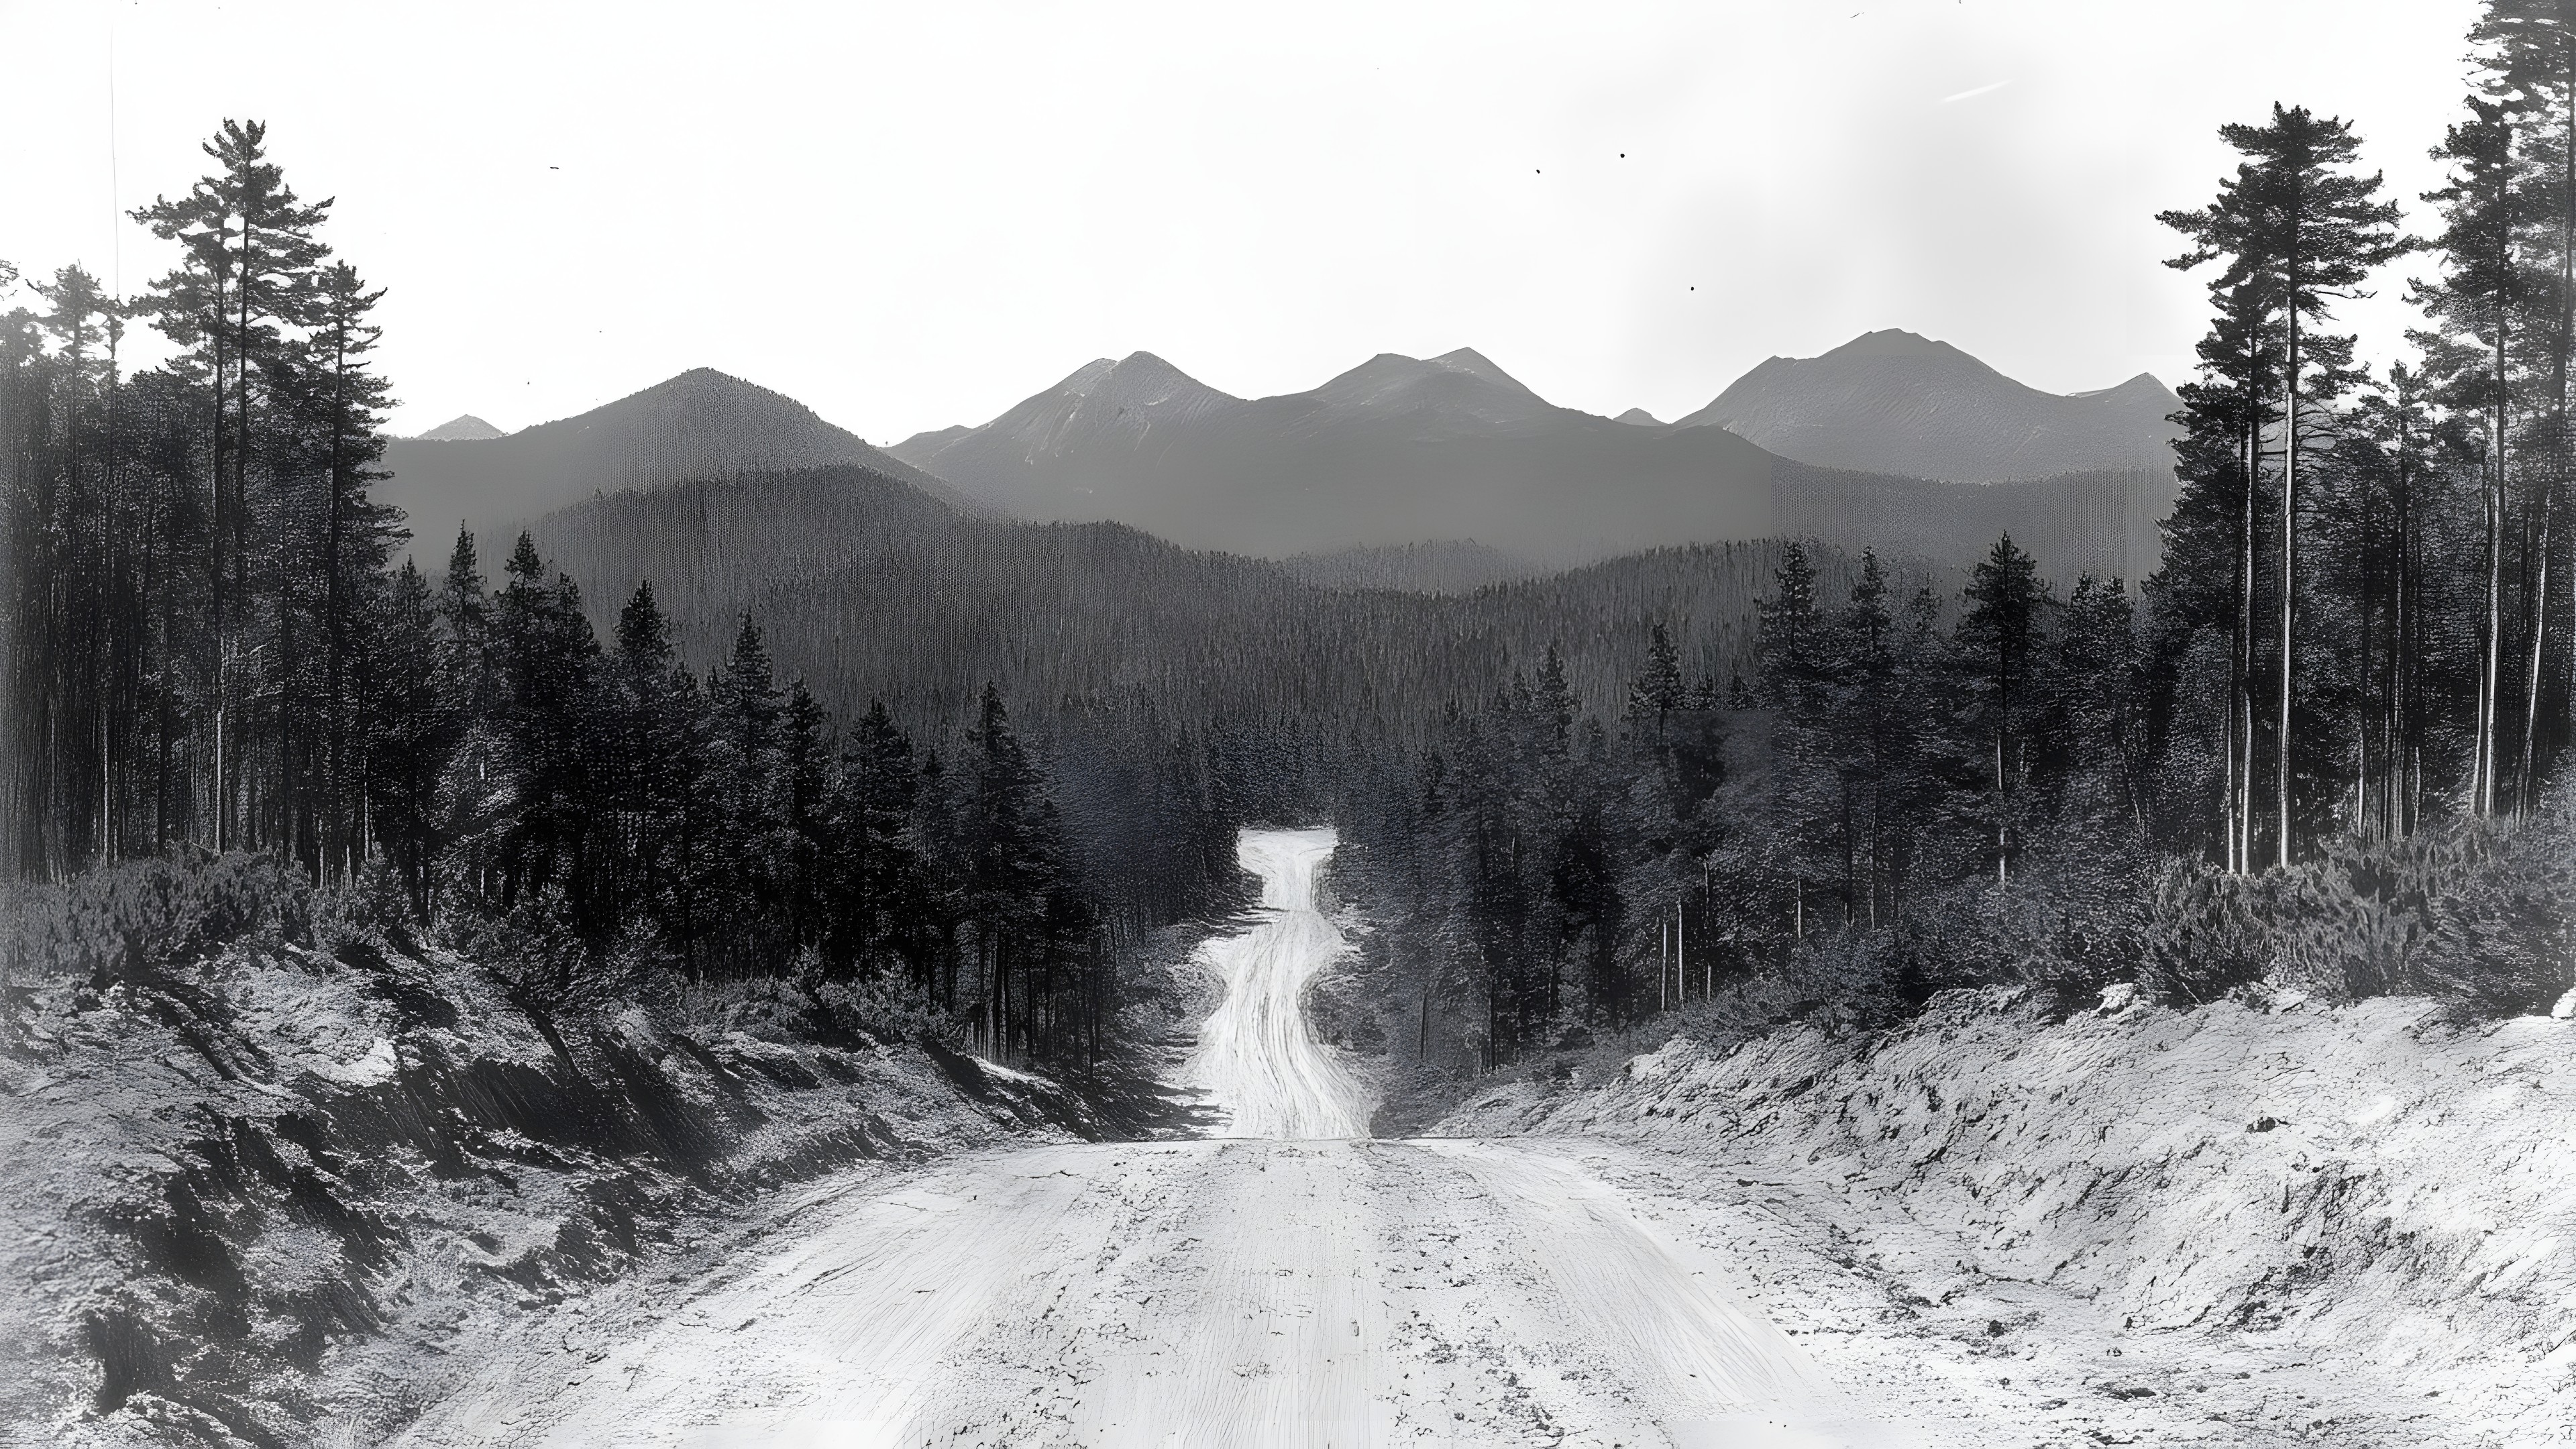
[{"left": 381, "top": 333, "right": 2177, "bottom": 593}]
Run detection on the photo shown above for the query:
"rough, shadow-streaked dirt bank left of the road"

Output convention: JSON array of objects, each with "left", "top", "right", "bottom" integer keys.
[{"left": 0, "top": 928, "right": 1100, "bottom": 1444}]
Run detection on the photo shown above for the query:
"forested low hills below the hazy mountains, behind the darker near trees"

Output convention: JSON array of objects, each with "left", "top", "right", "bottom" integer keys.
[{"left": 536, "top": 467, "right": 1875, "bottom": 737}]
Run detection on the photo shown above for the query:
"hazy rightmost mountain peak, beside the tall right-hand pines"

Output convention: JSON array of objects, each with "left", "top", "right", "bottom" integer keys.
[{"left": 1674, "top": 330, "right": 2182, "bottom": 482}]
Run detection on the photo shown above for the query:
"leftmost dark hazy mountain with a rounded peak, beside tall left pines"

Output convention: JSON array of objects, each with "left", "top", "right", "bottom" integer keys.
[{"left": 376, "top": 369, "right": 961, "bottom": 557}]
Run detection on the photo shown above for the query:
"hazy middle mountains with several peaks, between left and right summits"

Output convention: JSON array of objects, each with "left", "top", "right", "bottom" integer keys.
[{"left": 894, "top": 351, "right": 1772, "bottom": 568}]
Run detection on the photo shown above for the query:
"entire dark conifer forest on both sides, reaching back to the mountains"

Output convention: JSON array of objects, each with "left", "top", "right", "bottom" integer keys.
[{"left": 15, "top": 0, "right": 2576, "bottom": 1067}]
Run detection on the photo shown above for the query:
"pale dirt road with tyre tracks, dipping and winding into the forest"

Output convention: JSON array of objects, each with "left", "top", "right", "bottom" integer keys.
[{"left": 405, "top": 830, "right": 1901, "bottom": 1449}]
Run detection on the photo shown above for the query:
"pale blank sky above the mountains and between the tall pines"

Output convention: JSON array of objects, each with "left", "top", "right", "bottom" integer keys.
[{"left": 0, "top": 0, "right": 2475, "bottom": 441}]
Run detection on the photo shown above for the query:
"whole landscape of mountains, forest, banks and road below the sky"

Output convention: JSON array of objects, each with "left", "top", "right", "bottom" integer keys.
[{"left": 0, "top": 0, "right": 2576, "bottom": 1449}]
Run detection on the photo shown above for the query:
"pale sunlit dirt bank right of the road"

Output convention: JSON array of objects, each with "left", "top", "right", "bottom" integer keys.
[{"left": 1438, "top": 987, "right": 2576, "bottom": 1446}]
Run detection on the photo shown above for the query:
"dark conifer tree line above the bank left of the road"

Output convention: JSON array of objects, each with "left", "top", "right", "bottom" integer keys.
[{"left": 0, "top": 121, "right": 1113, "bottom": 1057}]
